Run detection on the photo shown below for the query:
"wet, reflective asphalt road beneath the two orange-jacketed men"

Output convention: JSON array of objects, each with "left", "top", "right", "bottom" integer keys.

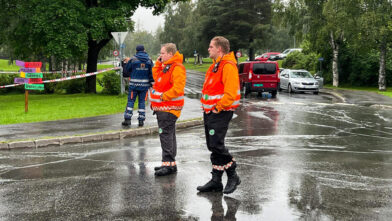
[{"left": 0, "top": 72, "right": 392, "bottom": 220}]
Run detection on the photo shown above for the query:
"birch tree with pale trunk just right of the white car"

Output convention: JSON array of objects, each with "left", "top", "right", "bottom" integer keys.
[{"left": 281, "top": 0, "right": 360, "bottom": 87}]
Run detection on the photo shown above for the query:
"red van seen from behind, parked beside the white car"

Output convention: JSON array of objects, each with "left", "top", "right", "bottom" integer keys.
[{"left": 238, "top": 61, "right": 280, "bottom": 97}]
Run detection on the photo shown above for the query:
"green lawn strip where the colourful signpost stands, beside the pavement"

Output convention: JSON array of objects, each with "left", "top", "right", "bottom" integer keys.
[{"left": 0, "top": 94, "right": 127, "bottom": 125}]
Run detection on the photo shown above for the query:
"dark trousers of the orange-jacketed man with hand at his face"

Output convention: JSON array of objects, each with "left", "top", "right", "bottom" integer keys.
[{"left": 156, "top": 111, "right": 177, "bottom": 162}]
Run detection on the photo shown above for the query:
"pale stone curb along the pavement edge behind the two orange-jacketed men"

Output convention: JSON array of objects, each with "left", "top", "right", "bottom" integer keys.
[{"left": 0, "top": 118, "right": 204, "bottom": 151}]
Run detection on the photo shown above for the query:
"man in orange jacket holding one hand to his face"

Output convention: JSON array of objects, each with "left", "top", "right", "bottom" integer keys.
[{"left": 149, "top": 43, "right": 186, "bottom": 176}]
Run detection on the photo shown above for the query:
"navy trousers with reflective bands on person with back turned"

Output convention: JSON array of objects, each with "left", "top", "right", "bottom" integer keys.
[{"left": 124, "top": 89, "right": 148, "bottom": 121}]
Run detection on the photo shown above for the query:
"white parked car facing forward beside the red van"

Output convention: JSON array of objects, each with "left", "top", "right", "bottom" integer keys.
[{"left": 279, "top": 69, "right": 320, "bottom": 94}]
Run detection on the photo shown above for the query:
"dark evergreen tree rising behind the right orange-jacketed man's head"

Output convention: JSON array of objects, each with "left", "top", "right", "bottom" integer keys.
[{"left": 198, "top": 0, "right": 271, "bottom": 60}]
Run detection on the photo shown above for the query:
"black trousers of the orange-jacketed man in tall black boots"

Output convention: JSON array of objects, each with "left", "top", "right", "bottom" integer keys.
[{"left": 203, "top": 111, "right": 233, "bottom": 165}]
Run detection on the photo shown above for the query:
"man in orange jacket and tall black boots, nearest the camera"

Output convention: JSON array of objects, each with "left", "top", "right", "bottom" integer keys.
[{"left": 197, "top": 36, "right": 241, "bottom": 194}]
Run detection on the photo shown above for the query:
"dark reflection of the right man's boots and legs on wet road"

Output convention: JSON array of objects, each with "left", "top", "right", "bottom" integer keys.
[{"left": 197, "top": 192, "right": 241, "bottom": 221}]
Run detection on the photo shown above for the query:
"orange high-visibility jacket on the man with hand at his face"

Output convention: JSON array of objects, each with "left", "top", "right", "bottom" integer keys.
[{"left": 149, "top": 51, "right": 186, "bottom": 117}]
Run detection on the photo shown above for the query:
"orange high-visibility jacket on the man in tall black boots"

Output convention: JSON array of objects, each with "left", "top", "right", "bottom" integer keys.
[{"left": 200, "top": 52, "right": 241, "bottom": 113}]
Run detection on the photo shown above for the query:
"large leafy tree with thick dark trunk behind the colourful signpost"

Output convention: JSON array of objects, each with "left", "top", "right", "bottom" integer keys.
[{"left": 0, "top": 0, "right": 184, "bottom": 93}]
